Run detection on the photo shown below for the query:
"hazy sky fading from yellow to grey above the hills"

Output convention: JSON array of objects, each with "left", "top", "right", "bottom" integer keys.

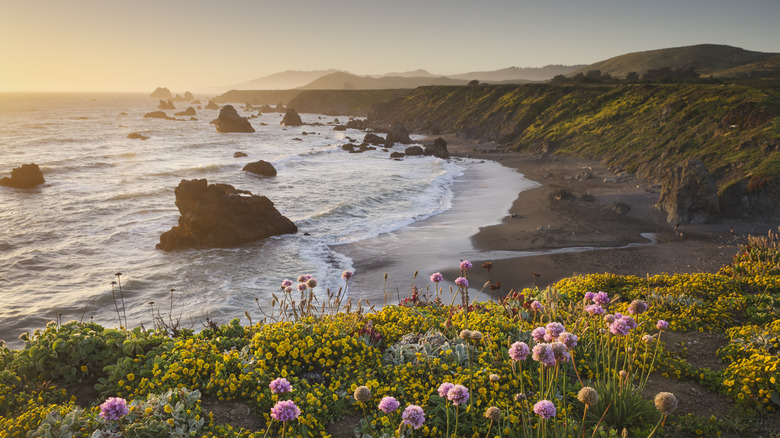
[{"left": 0, "top": 0, "right": 780, "bottom": 93}]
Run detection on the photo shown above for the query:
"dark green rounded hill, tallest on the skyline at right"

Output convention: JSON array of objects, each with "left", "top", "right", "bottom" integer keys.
[{"left": 568, "top": 44, "right": 778, "bottom": 77}]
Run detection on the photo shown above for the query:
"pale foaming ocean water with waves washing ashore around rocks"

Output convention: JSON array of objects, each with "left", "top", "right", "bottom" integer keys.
[{"left": 0, "top": 94, "right": 536, "bottom": 345}]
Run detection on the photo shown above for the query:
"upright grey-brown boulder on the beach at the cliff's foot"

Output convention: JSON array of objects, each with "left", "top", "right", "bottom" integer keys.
[{"left": 656, "top": 158, "right": 721, "bottom": 224}]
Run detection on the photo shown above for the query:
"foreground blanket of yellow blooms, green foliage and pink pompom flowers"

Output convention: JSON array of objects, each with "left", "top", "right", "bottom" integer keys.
[{"left": 0, "top": 233, "right": 780, "bottom": 438}]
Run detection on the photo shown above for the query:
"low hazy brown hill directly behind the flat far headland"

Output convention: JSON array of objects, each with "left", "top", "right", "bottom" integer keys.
[{"left": 298, "top": 72, "right": 469, "bottom": 90}]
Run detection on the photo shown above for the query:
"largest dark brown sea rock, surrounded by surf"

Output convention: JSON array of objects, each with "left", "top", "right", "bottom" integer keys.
[{"left": 157, "top": 179, "right": 298, "bottom": 251}]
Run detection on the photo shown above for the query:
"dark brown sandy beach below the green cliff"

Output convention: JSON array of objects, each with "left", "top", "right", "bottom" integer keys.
[{"left": 432, "top": 135, "right": 777, "bottom": 293}]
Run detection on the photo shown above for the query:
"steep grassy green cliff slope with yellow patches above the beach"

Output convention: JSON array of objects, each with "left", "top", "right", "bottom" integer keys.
[{"left": 369, "top": 83, "right": 780, "bottom": 217}]
